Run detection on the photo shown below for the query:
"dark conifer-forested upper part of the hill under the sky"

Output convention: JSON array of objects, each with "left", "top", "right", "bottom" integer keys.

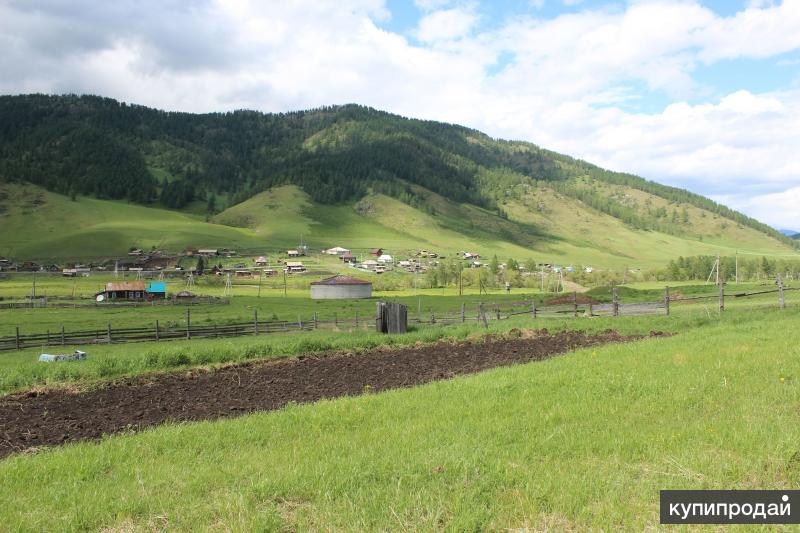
[{"left": 0, "top": 95, "right": 791, "bottom": 243}]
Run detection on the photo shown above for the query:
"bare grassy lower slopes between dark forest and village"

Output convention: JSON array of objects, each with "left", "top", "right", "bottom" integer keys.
[{"left": 0, "top": 184, "right": 791, "bottom": 268}]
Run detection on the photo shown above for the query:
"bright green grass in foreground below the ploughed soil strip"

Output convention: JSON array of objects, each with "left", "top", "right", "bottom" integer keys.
[{"left": 0, "top": 302, "right": 800, "bottom": 531}]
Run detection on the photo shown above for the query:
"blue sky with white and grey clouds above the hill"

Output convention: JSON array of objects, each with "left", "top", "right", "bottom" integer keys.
[{"left": 0, "top": 0, "right": 800, "bottom": 230}]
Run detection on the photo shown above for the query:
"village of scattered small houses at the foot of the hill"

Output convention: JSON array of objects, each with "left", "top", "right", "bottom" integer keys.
[{"left": 0, "top": 244, "right": 594, "bottom": 304}]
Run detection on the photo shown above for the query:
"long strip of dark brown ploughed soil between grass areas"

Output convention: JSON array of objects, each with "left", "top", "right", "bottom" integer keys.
[{"left": 0, "top": 330, "right": 648, "bottom": 457}]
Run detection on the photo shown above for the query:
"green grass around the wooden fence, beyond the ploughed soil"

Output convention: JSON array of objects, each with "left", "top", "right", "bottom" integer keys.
[{"left": 0, "top": 285, "right": 800, "bottom": 393}]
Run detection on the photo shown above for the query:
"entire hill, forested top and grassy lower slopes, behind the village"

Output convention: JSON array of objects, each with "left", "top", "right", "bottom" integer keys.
[{"left": 0, "top": 95, "right": 797, "bottom": 267}]
